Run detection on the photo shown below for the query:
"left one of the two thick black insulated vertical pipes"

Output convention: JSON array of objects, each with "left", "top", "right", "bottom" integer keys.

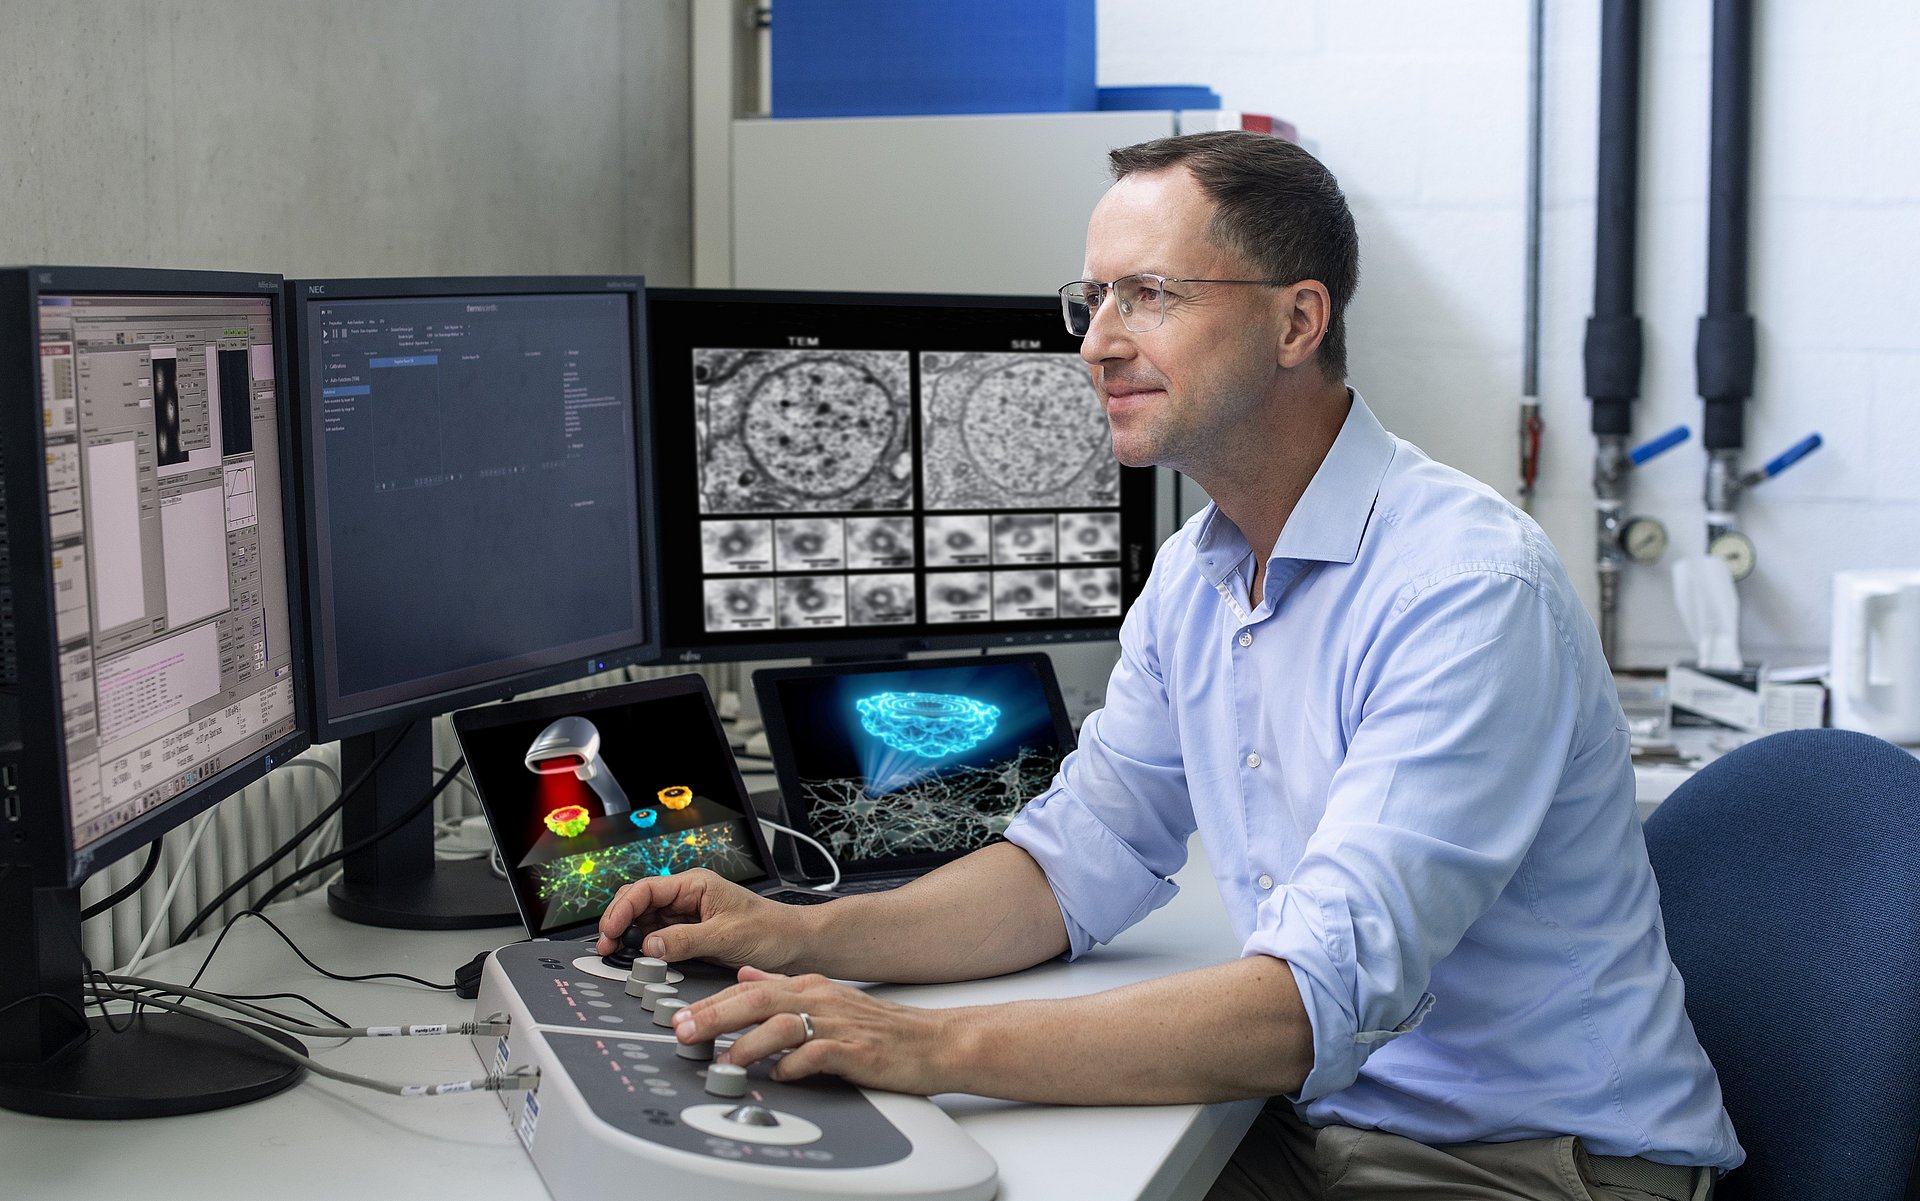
[{"left": 1586, "top": 0, "right": 1642, "bottom": 436}]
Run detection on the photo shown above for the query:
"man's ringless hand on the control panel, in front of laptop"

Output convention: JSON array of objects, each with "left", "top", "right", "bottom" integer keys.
[{"left": 597, "top": 867, "right": 795, "bottom": 971}]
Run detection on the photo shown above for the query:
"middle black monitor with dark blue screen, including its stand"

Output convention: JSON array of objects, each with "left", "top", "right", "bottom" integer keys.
[{"left": 288, "top": 276, "right": 657, "bottom": 929}]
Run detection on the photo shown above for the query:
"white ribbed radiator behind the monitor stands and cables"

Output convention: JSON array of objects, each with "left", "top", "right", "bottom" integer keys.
[{"left": 81, "top": 664, "right": 747, "bottom": 971}]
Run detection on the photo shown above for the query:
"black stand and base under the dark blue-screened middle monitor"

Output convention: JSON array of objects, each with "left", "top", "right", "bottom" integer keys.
[{"left": 326, "top": 719, "right": 520, "bottom": 930}]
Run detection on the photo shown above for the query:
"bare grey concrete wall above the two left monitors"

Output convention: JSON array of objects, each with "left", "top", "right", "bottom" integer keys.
[{"left": 0, "top": 0, "right": 691, "bottom": 284}]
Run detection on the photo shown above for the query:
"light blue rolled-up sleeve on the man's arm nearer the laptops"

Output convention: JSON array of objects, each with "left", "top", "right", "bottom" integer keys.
[{"left": 1006, "top": 552, "right": 1194, "bottom": 957}]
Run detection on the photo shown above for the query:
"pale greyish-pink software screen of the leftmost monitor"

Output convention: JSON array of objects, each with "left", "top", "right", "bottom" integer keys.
[{"left": 38, "top": 295, "right": 296, "bottom": 848}]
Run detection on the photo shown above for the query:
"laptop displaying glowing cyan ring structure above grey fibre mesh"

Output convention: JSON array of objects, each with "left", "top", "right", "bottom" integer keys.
[{"left": 753, "top": 654, "right": 1073, "bottom": 892}]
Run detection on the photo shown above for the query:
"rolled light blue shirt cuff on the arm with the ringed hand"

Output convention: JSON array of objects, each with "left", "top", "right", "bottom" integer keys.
[{"left": 1240, "top": 884, "right": 1434, "bottom": 1103}]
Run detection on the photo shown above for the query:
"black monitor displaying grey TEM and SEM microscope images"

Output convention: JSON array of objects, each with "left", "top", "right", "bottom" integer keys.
[{"left": 647, "top": 290, "right": 1154, "bottom": 662}]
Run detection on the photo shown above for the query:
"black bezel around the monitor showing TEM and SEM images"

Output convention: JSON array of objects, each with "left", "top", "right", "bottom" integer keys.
[{"left": 649, "top": 288, "right": 1160, "bottom": 666}]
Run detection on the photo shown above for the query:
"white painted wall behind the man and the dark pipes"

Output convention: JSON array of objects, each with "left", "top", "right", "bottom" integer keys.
[{"left": 1098, "top": 0, "right": 1920, "bottom": 664}]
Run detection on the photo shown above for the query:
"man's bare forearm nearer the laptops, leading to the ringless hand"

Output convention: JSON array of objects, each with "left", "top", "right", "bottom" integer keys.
[{"left": 783, "top": 842, "right": 1068, "bottom": 984}]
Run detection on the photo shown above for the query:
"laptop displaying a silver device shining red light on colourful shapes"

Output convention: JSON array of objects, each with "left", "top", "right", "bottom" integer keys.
[{"left": 453, "top": 675, "right": 831, "bottom": 938}]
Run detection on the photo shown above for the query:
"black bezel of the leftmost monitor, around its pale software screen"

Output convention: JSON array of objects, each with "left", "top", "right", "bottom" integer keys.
[{"left": 0, "top": 267, "right": 311, "bottom": 888}]
